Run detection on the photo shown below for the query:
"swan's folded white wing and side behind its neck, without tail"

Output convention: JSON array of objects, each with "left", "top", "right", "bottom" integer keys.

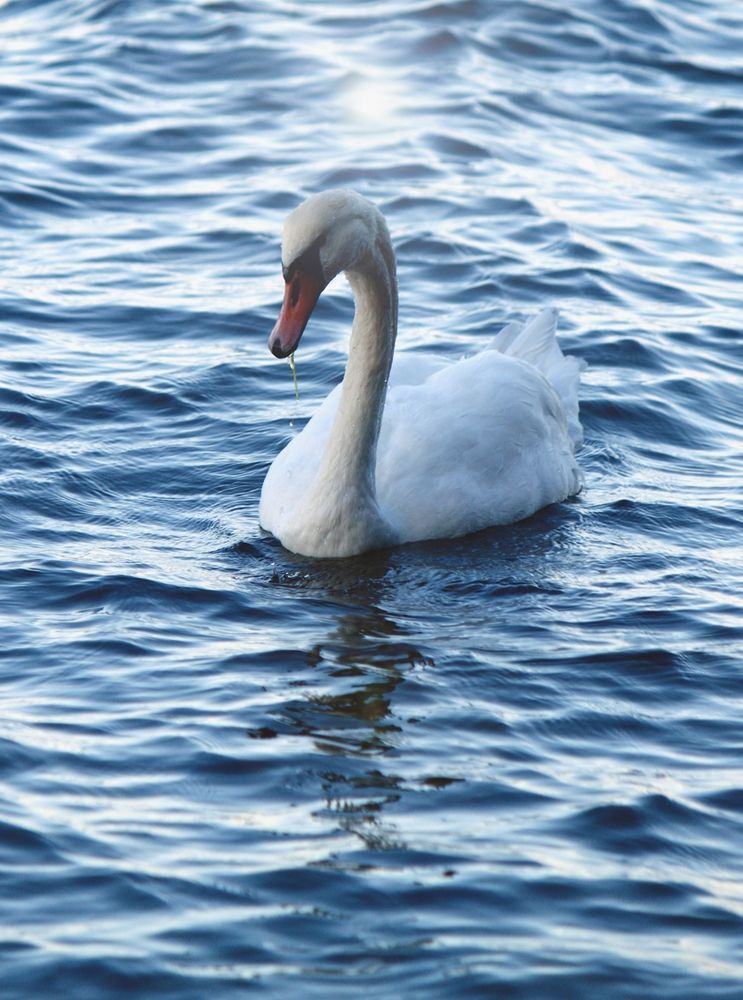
[{"left": 377, "top": 351, "right": 580, "bottom": 541}]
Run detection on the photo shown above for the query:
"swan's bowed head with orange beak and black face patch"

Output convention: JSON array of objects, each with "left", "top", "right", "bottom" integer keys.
[{"left": 268, "top": 190, "right": 385, "bottom": 358}]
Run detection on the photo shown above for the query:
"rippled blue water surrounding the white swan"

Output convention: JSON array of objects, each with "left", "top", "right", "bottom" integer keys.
[{"left": 0, "top": 0, "right": 743, "bottom": 1000}]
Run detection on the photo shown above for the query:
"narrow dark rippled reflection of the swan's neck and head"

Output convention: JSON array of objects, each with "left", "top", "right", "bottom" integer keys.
[{"left": 262, "top": 552, "right": 433, "bottom": 865}]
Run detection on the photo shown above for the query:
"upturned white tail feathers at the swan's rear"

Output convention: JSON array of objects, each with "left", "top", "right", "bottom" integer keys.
[{"left": 493, "top": 309, "right": 586, "bottom": 448}]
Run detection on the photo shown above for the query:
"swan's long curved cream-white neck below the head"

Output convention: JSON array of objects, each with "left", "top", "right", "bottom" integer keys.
[{"left": 312, "top": 233, "right": 397, "bottom": 548}]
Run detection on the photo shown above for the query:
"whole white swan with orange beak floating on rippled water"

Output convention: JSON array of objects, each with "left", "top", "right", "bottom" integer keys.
[{"left": 259, "top": 190, "right": 581, "bottom": 556}]
